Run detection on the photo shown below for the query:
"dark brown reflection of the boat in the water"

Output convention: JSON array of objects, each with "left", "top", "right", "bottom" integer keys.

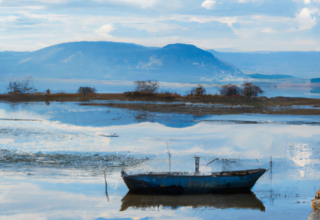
[{"left": 120, "top": 192, "right": 265, "bottom": 212}]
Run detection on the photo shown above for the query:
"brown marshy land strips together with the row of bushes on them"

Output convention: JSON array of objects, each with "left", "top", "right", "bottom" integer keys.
[{"left": 0, "top": 78, "right": 320, "bottom": 116}]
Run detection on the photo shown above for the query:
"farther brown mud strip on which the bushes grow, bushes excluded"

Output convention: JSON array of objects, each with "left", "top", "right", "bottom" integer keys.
[{"left": 0, "top": 92, "right": 320, "bottom": 107}]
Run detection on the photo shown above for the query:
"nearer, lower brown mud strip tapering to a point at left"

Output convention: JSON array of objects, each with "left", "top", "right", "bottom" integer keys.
[{"left": 80, "top": 103, "right": 320, "bottom": 116}]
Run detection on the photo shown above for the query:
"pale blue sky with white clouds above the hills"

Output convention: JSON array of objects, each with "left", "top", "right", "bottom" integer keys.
[{"left": 0, "top": 0, "right": 320, "bottom": 51}]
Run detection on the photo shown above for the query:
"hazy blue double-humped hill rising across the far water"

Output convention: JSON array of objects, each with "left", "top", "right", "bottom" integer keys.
[{"left": 0, "top": 42, "right": 246, "bottom": 82}]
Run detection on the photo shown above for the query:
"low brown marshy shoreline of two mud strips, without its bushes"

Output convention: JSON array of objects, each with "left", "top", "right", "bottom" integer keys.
[{"left": 0, "top": 92, "right": 320, "bottom": 116}]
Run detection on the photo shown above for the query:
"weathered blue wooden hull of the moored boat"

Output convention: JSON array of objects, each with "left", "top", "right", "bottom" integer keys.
[{"left": 122, "top": 169, "right": 266, "bottom": 194}]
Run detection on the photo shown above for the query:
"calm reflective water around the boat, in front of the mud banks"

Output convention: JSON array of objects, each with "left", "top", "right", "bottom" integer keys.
[{"left": 0, "top": 102, "right": 320, "bottom": 220}]
